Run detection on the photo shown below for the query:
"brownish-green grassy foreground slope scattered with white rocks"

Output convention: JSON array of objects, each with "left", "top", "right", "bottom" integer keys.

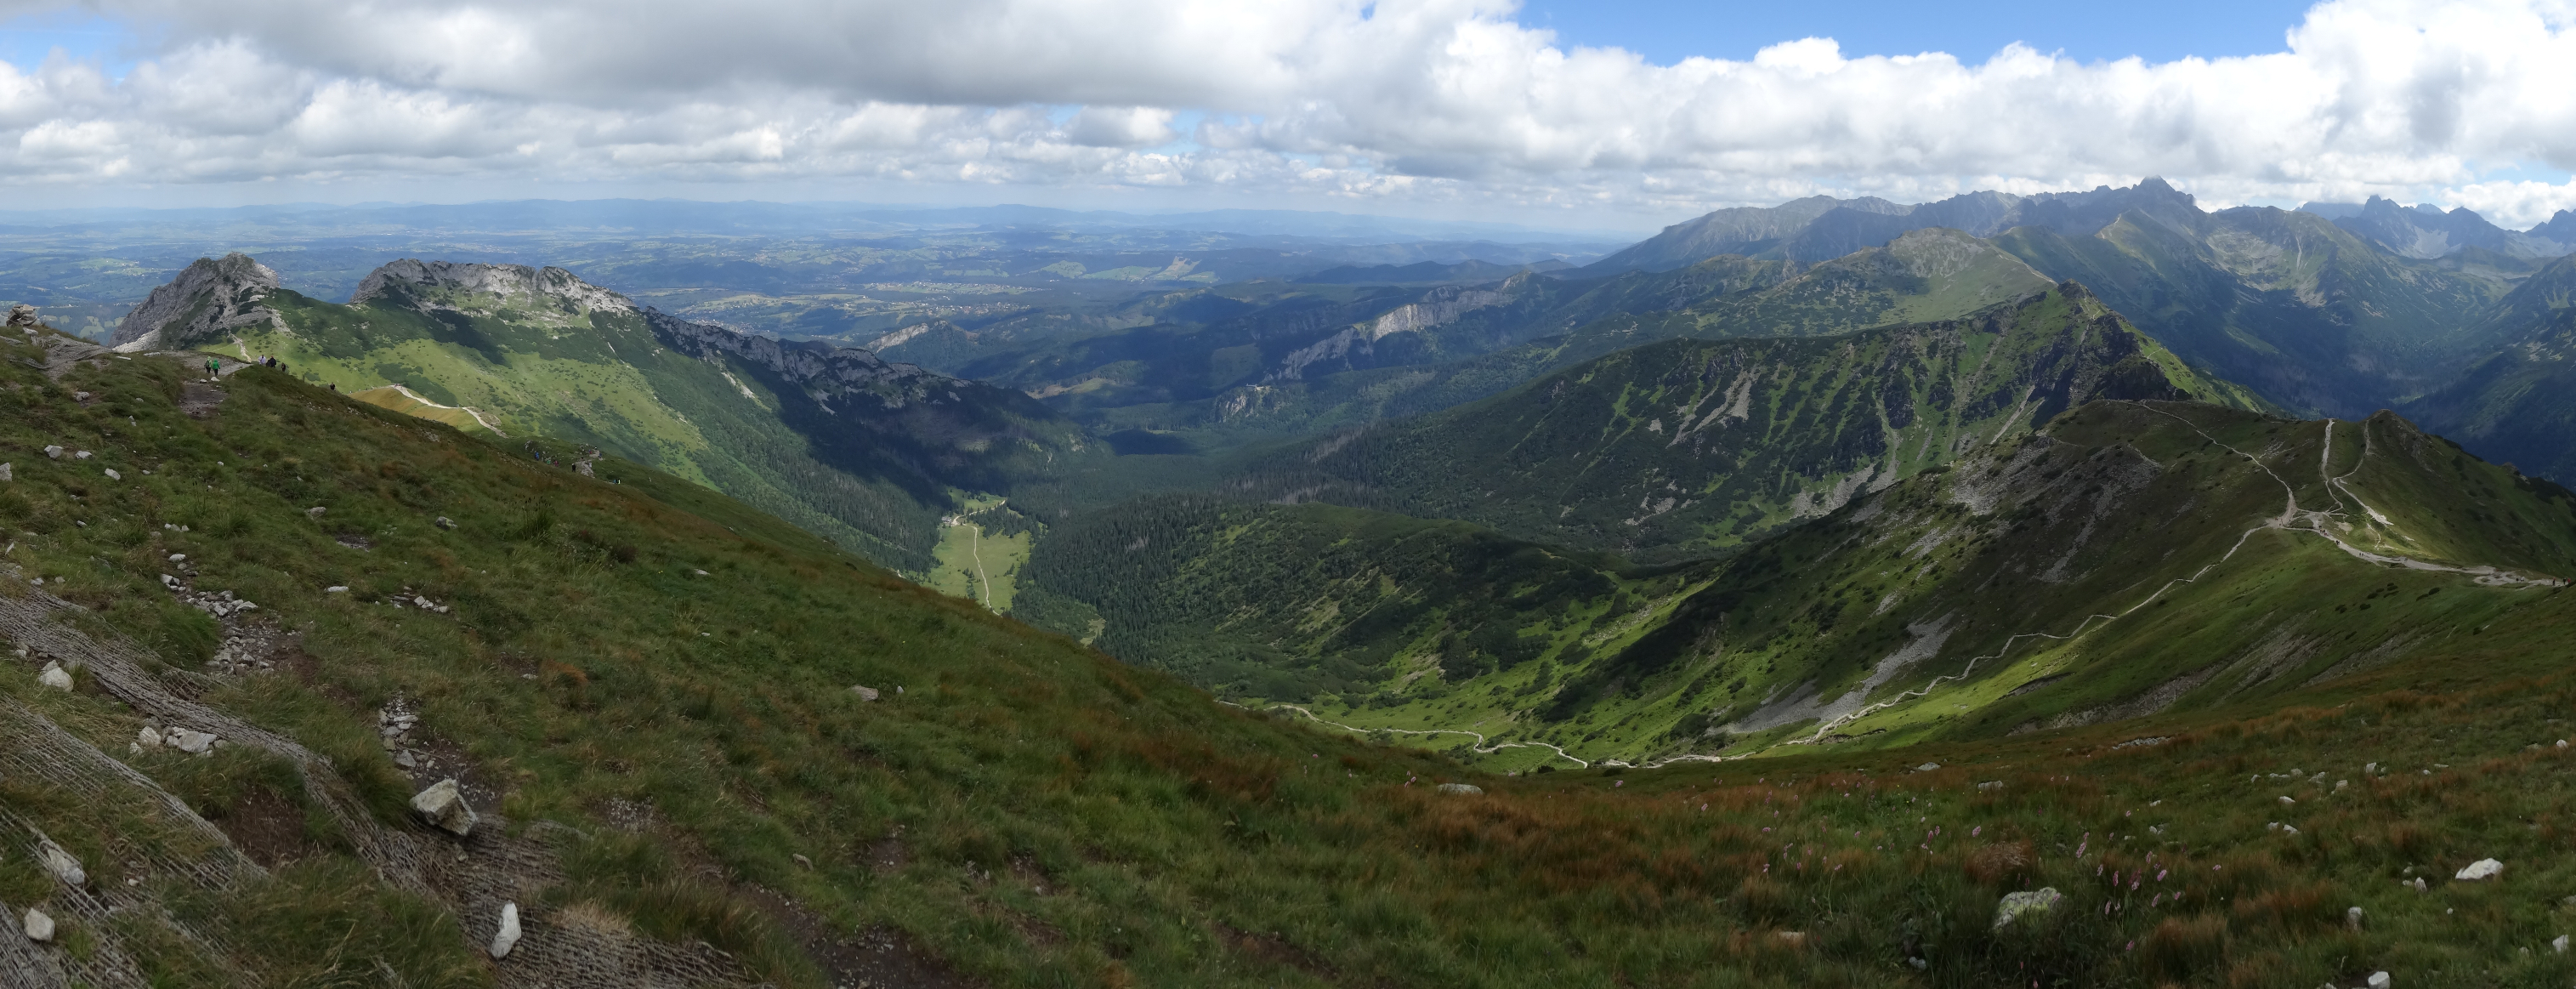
[{"left": 14, "top": 321, "right": 2576, "bottom": 986}]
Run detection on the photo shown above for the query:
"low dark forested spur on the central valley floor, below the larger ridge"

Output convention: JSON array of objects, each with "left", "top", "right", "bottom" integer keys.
[{"left": 1015, "top": 495, "right": 1705, "bottom": 721}]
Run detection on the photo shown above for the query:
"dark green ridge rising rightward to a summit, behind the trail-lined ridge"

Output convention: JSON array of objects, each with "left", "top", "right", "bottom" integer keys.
[{"left": 1244, "top": 286, "right": 2244, "bottom": 556}]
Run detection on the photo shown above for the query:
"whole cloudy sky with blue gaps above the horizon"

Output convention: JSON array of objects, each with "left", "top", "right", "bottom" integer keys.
[{"left": 0, "top": 0, "right": 2576, "bottom": 230}]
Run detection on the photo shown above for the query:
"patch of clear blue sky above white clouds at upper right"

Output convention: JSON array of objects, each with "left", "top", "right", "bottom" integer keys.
[{"left": 1518, "top": 0, "right": 2308, "bottom": 65}]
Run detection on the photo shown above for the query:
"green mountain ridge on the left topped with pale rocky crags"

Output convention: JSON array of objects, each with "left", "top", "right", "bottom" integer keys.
[{"left": 163, "top": 263, "right": 1082, "bottom": 571}]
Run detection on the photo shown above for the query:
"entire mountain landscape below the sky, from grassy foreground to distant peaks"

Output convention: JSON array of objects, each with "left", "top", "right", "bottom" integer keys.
[{"left": 14, "top": 180, "right": 2576, "bottom": 986}]
